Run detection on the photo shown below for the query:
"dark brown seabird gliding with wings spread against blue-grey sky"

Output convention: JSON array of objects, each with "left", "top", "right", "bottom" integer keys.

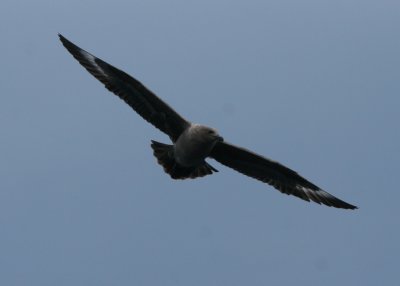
[{"left": 59, "top": 34, "right": 357, "bottom": 209}]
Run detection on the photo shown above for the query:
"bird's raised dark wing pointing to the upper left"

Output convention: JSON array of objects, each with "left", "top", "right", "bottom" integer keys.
[{"left": 59, "top": 34, "right": 189, "bottom": 142}]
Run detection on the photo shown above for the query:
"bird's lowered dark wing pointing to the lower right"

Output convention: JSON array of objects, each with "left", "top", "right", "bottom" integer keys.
[{"left": 210, "top": 142, "right": 357, "bottom": 209}]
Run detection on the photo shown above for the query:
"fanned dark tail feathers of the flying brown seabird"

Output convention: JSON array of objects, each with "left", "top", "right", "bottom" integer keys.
[{"left": 151, "top": 140, "right": 218, "bottom": 180}]
